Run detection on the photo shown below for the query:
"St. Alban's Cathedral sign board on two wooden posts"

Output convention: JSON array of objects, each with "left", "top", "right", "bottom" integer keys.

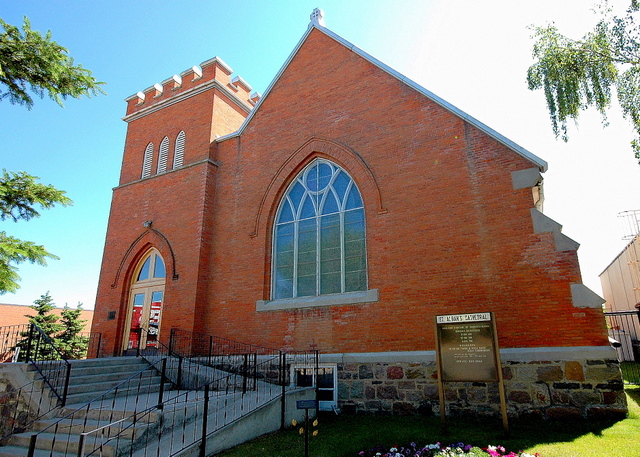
[{"left": 435, "top": 313, "right": 509, "bottom": 436}]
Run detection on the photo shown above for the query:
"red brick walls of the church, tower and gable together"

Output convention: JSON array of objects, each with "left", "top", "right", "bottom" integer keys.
[{"left": 94, "top": 30, "right": 607, "bottom": 360}]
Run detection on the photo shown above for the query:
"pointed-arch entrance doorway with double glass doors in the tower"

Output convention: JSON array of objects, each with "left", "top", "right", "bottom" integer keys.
[{"left": 123, "top": 249, "right": 166, "bottom": 352}]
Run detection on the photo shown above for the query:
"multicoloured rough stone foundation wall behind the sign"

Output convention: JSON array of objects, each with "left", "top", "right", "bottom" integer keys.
[{"left": 323, "top": 348, "right": 627, "bottom": 419}]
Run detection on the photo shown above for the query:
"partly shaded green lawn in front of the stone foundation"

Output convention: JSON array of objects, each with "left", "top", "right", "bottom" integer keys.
[{"left": 214, "top": 386, "right": 640, "bottom": 457}]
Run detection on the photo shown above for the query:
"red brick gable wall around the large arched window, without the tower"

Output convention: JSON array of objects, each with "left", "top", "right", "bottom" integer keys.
[{"left": 202, "top": 31, "right": 606, "bottom": 352}]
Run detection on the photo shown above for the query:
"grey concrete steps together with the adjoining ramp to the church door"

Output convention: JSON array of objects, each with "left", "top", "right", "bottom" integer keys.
[{"left": 0, "top": 358, "right": 288, "bottom": 457}]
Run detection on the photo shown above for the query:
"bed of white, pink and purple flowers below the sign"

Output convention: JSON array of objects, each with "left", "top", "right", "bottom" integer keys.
[{"left": 358, "top": 443, "right": 540, "bottom": 457}]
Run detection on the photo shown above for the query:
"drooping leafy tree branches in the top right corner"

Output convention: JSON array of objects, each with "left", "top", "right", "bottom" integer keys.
[{"left": 527, "top": 0, "right": 640, "bottom": 162}]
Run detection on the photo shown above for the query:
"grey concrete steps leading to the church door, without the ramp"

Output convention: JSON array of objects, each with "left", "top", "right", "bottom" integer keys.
[{"left": 0, "top": 357, "right": 162, "bottom": 457}]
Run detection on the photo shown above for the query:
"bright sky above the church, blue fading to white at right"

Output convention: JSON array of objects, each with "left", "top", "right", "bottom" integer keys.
[{"left": 0, "top": 0, "right": 640, "bottom": 308}]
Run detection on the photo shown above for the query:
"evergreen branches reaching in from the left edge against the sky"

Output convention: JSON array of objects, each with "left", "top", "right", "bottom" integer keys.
[{"left": 0, "top": 17, "right": 104, "bottom": 295}]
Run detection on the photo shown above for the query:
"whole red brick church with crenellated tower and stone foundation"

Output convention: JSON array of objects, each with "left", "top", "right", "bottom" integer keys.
[{"left": 92, "top": 10, "right": 626, "bottom": 417}]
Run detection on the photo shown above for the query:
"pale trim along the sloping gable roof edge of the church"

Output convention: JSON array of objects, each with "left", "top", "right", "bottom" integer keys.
[{"left": 216, "top": 21, "right": 548, "bottom": 172}]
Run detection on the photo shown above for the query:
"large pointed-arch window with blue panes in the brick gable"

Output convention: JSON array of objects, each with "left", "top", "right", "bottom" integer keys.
[{"left": 272, "top": 159, "right": 367, "bottom": 299}]
